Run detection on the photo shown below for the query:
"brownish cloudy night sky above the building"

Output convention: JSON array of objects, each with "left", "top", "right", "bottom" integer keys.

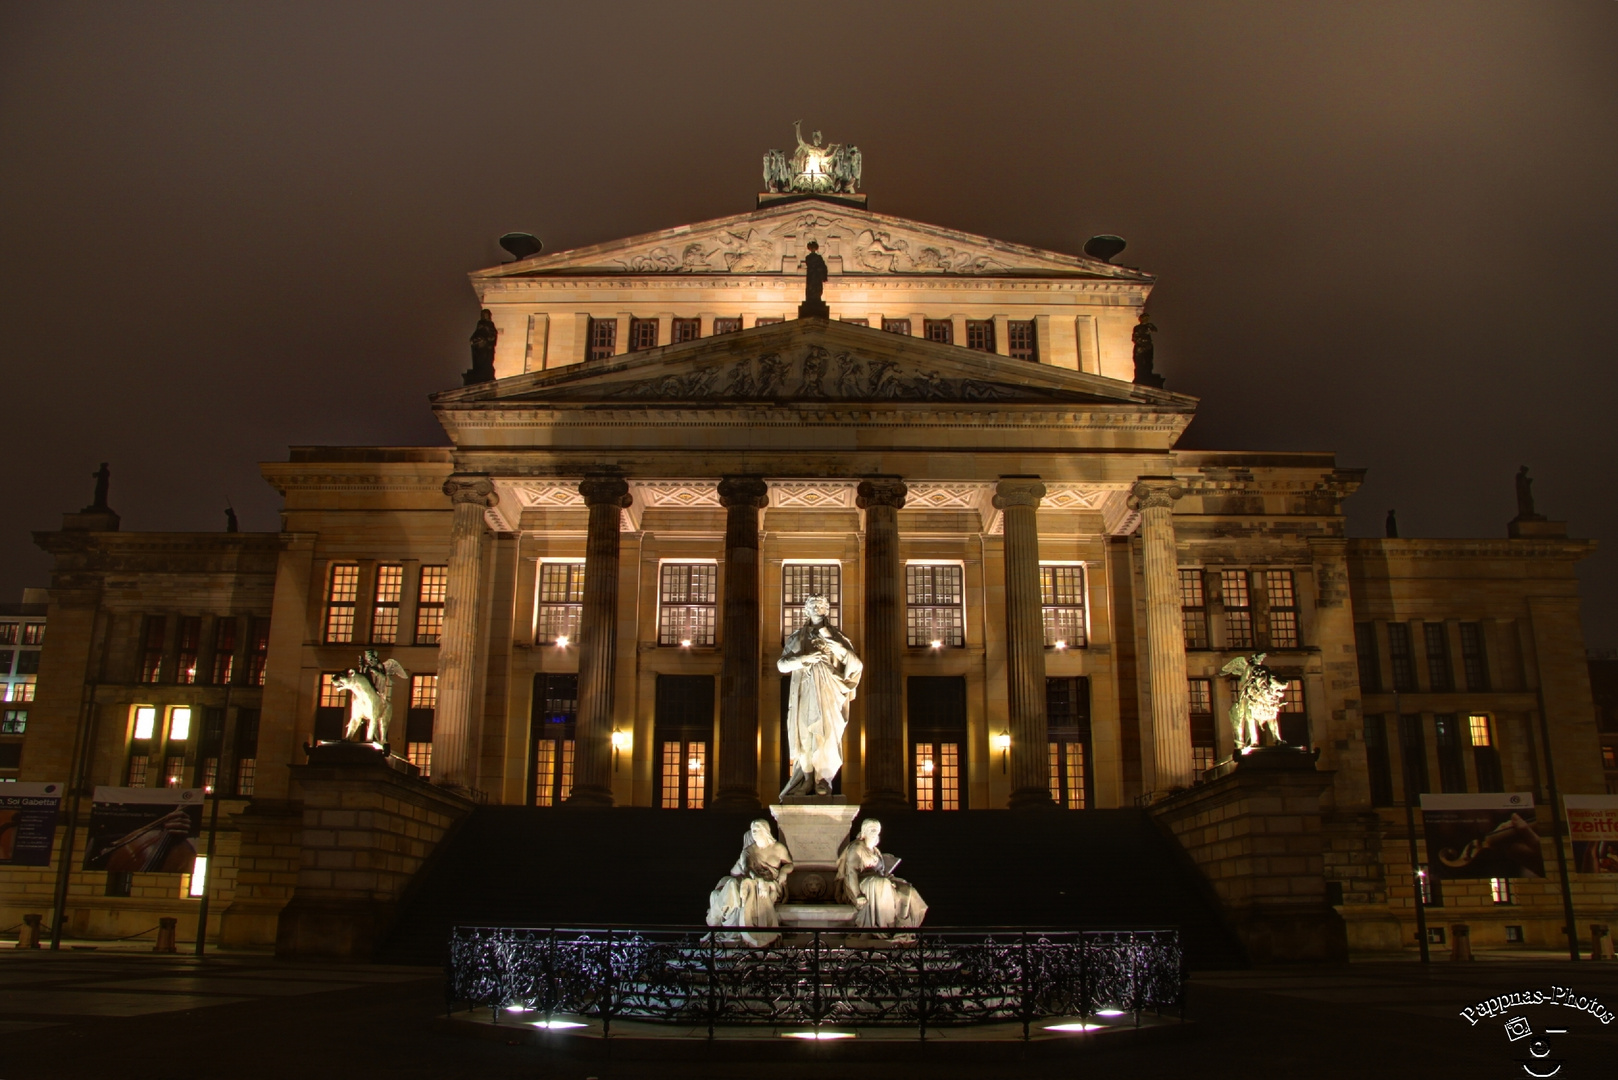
[{"left": 0, "top": 0, "right": 1618, "bottom": 648}]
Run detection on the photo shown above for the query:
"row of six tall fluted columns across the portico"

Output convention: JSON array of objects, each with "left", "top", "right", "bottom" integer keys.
[{"left": 434, "top": 473, "right": 1191, "bottom": 811}]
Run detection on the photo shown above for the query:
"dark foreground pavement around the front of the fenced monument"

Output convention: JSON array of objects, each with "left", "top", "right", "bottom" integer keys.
[{"left": 0, "top": 950, "right": 1618, "bottom": 1080}]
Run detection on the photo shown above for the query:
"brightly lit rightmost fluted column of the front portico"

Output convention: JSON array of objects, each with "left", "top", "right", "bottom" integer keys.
[{"left": 1129, "top": 476, "right": 1194, "bottom": 792}]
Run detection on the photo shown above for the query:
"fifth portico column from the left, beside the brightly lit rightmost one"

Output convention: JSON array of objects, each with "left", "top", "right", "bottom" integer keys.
[{"left": 995, "top": 476, "right": 1052, "bottom": 810}]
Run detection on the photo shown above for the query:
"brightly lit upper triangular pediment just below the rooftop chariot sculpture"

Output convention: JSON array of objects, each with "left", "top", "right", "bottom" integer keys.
[{"left": 472, "top": 199, "right": 1152, "bottom": 285}]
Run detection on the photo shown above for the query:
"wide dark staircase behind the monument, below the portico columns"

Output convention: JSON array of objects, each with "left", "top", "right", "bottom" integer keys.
[{"left": 382, "top": 806, "right": 1244, "bottom": 968}]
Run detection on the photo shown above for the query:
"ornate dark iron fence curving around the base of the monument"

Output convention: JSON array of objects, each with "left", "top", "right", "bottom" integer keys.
[{"left": 445, "top": 926, "right": 1183, "bottom": 1036}]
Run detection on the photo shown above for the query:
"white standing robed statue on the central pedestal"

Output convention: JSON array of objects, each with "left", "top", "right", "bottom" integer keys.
[{"left": 775, "top": 596, "right": 864, "bottom": 798}]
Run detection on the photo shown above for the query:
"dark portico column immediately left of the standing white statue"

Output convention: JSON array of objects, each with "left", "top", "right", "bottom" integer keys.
[{"left": 714, "top": 476, "right": 770, "bottom": 813}]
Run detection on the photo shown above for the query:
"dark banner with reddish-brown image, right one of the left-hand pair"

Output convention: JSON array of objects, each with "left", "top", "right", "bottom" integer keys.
[{"left": 84, "top": 787, "right": 202, "bottom": 874}]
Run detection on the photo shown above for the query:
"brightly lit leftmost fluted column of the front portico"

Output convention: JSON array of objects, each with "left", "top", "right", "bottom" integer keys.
[{"left": 432, "top": 473, "right": 500, "bottom": 792}]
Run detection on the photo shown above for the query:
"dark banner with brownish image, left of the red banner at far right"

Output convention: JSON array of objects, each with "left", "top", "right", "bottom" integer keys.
[{"left": 1421, "top": 792, "right": 1545, "bottom": 881}]
